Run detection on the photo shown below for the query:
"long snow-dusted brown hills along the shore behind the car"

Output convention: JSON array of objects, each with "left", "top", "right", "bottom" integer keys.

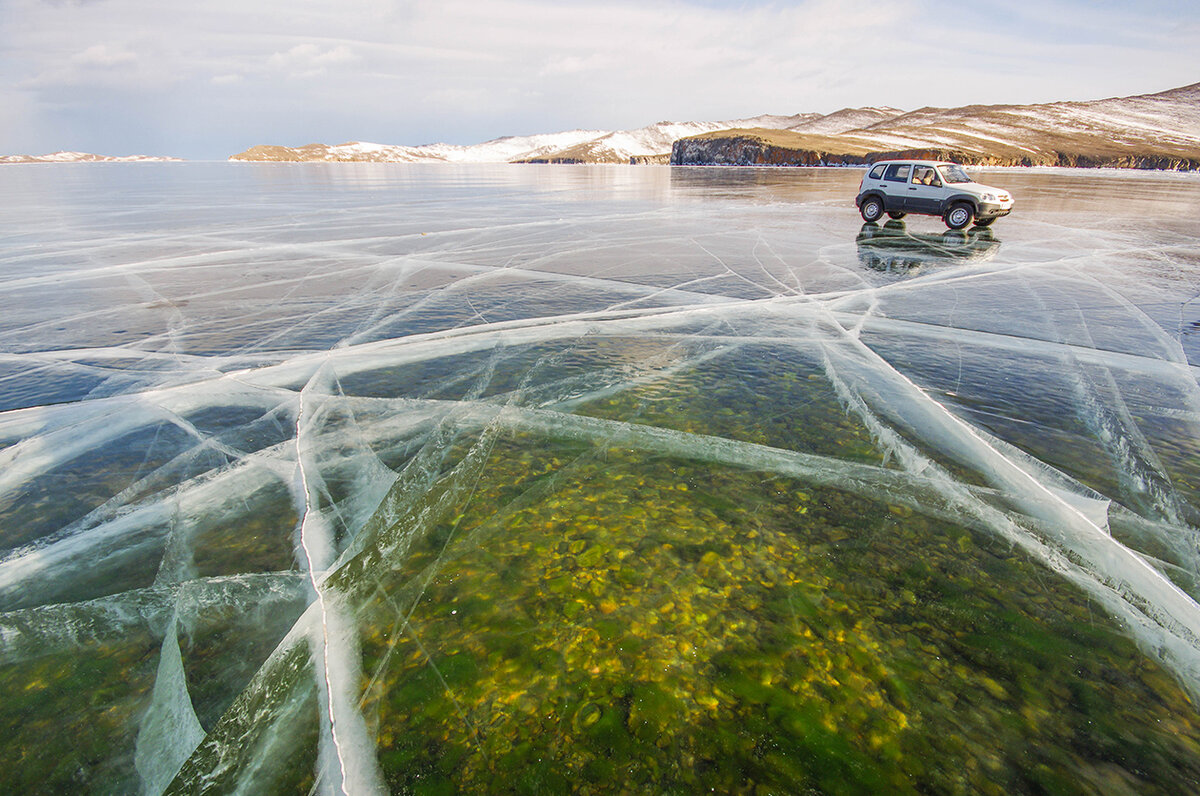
[{"left": 229, "top": 83, "right": 1200, "bottom": 170}]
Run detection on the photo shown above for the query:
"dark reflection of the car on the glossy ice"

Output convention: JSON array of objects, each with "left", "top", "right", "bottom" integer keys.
[{"left": 854, "top": 221, "right": 1000, "bottom": 276}]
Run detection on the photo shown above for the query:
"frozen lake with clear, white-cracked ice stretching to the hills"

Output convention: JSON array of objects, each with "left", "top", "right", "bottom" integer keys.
[{"left": 0, "top": 163, "right": 1200, "bottom": 795}]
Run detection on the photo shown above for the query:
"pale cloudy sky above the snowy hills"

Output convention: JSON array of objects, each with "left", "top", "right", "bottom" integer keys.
[{"left": 0, "top": 0, "right": 1200, "bottom": 160}]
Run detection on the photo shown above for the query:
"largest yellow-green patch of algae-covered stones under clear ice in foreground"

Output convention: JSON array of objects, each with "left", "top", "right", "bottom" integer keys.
[{"left": 350, "top": 441, "right": 1200, "bottom": 794}]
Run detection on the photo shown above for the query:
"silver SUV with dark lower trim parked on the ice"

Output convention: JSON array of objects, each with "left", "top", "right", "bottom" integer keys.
[{"left": 854, "top": 161, "right": 1013, "bottom": 229}]
